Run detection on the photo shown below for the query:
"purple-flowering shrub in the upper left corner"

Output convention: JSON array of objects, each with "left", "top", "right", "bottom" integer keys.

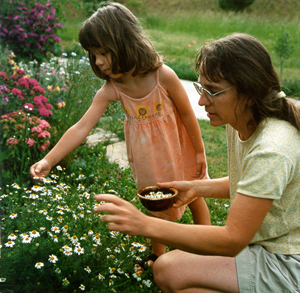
[{"left": 0, "top": 0, "right": 62, "bottom": 62}]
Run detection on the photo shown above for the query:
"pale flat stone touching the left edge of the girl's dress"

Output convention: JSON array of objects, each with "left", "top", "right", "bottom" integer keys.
[{"left": 106, "top": 141, "right": 129, "bottom": 169}]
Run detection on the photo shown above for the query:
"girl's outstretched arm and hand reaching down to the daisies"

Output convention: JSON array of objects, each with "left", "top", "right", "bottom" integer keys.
[{"left": 30, "top": 82, "right": 117, "bottom": 177}]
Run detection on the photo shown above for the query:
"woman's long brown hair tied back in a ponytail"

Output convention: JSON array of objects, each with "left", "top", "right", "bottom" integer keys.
[{"left": 195, "top": 33, "right": 300, "bottom": 130}]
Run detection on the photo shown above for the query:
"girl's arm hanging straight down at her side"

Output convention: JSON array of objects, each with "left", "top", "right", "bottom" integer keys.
[{"left": 160, "top": 65, "right": 207, "bottom": 178}]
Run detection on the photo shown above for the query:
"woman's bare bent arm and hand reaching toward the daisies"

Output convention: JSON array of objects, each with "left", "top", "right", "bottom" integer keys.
[{"left": 95, "top": 194, "right": 273, "bottom": 256}]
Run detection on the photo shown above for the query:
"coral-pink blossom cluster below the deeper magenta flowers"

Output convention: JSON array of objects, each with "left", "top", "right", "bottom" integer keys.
[{"left": 0, "top": 111, "right": 51, "bottom": 151}]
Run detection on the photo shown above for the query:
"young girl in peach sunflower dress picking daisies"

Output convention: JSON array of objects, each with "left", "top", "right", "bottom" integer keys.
[{"left": 30, "top": 3, "right": 210, "bottom": 266}]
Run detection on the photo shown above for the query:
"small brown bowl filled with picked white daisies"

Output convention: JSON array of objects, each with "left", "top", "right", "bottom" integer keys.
[{"left": 137, "top": 186, "right": 178, "bottom": 212}]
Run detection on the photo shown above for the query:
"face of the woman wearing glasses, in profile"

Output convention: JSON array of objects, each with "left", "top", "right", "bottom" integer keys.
[{"left": 198, "top": 74, "right": 253, "bottom": 139}]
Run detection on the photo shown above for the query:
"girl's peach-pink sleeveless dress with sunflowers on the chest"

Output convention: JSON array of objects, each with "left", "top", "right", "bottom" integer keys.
[{"left": 111, "top": 70, "right": 196, "bottom": 221}]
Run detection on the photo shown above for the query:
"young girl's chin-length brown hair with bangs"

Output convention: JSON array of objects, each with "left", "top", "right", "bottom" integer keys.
[{"left": 79, "top": 2, "right": 162, "bottom": 80}]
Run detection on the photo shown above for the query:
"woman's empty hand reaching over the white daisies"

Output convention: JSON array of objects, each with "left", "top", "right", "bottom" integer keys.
[{"left": 94, "top": 194, "right": 148, "bottom": 236}]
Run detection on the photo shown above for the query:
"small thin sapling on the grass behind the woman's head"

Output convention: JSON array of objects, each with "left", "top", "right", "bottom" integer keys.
[{"left": 274, "top": 30, "right": 295, "bottom": 78}]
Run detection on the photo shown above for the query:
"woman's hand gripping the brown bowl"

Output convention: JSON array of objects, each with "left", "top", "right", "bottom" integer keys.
[{"left": 157, "top": 181, "right": 196, "bottom": 208}]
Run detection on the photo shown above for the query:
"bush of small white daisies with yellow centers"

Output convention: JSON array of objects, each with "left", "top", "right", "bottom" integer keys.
[{"left": 0, "top": 166, "right": 158, "bottom": 293}]
